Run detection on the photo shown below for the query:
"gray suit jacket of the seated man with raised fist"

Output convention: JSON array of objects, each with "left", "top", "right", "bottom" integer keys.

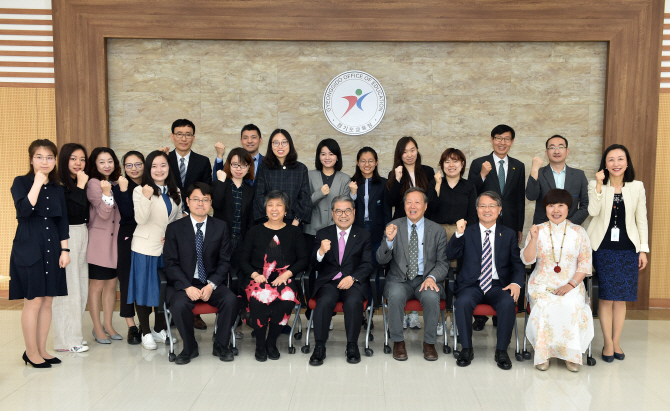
[{"left": 377, "top": 217, "right": 449, "bottom": 284}]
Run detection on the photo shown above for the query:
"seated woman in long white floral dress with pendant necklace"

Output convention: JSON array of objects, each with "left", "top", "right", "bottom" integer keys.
[{"left": 521, "top": 189, "right": 593, "bottom": 372}]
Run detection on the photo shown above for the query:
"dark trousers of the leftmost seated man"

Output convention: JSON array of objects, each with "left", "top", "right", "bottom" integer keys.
[{"left": 166, "top": 280, "right": 239, "bottom": 354}]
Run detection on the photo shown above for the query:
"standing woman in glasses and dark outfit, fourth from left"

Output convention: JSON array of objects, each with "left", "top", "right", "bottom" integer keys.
[{"left": 112, "top": 151, "right": 144, "bottom": 345}]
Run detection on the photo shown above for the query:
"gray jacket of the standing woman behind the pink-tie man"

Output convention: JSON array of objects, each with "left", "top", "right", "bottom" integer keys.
[{"left": 305, "top": 170, "right": 351, "bottom": 235}]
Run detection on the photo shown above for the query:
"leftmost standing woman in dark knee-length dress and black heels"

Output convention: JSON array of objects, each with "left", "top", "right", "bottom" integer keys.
[{"left": 9, "top": 140, "right": 70, "bottom": 368}]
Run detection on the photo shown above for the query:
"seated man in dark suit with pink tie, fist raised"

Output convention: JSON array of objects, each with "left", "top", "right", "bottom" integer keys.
[{"left": 309, "top": 195, "right": 372, "bottom": 365}]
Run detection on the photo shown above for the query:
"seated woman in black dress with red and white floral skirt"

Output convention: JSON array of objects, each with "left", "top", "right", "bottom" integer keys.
[{"left": 240, "top": 190, "right": 309, "bottom": 362}]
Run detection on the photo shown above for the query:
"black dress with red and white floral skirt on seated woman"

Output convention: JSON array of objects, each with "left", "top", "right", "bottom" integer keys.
[{"left": 240, "top": 224, "right": 309, "bottom": 330}]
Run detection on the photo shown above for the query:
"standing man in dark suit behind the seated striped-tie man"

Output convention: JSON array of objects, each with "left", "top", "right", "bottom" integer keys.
[{"left": 468, "top": 124, "right": 526, "bottom": 331}]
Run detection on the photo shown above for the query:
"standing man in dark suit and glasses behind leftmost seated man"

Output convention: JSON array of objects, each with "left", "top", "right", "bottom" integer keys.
[{"left": 161, "top": 119, "right": 212, "bottom": 330}]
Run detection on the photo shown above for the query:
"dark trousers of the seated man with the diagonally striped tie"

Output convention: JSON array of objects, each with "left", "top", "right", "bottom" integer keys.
[{"left": 454, "top": 280, "right": 516, "bottom": 350}]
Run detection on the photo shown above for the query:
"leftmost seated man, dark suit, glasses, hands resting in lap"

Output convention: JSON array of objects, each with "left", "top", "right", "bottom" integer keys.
[{"left": 163, "top": 183, "right": 239, "bottom": 364}]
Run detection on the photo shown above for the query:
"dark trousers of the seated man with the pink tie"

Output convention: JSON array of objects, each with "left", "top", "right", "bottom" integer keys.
[{"left": 312, "top": 280, "right": 365, "bottom": 344}]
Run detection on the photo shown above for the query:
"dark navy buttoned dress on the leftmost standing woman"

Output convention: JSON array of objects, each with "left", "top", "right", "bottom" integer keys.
[{"left": 9, "top": 174, "right": 70, "bottom": 300}]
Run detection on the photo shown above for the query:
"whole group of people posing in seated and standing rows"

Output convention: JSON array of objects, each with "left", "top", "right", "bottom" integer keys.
[{"left": 10, "top": 119, "right": 649, "bottom": 371}]
